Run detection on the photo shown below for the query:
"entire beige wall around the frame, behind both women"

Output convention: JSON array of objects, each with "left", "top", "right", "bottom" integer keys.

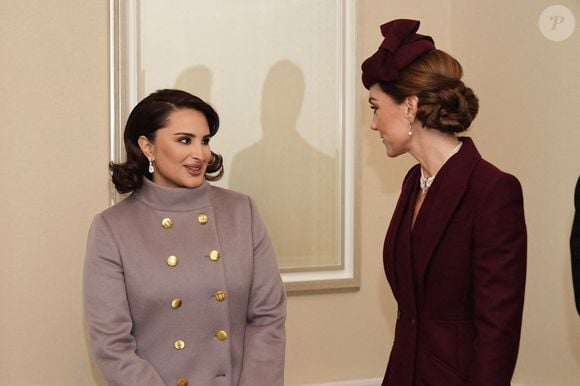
[{"left": 0, "top": 0, "right": 580, "bottom": 386}]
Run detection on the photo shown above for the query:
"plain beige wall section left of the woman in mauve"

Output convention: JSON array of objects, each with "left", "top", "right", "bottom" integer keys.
[{"left": 0, "top": 0, "right": 108, "bottom": 386}]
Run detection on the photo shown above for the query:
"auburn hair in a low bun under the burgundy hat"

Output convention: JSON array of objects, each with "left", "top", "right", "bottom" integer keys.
[{"left": 379, "top": 49, "right": 479, "bottom": 133}]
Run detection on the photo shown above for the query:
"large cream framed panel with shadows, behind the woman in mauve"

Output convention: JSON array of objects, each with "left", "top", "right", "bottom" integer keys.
[{"left": 110, "top": 0, "right": 359, "bottom": 292}]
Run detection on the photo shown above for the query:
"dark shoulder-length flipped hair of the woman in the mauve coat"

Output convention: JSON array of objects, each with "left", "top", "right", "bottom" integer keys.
[{"left": 109, "top": 89, "right": 224, "bottom": 193}]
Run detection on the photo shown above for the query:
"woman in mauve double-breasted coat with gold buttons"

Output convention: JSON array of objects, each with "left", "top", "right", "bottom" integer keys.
[{"left": 84, "top": 90, "right": 286, "bottom": 386}]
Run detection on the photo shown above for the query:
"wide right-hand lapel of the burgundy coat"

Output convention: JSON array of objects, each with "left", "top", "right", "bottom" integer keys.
[{"left": 414, "top": 137, "right": 481, "bottom": 304}]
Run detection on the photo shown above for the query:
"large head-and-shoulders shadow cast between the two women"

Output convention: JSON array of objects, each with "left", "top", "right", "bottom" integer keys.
[{"left": 229, "top": 60, "right": 341, "bottom": 271}]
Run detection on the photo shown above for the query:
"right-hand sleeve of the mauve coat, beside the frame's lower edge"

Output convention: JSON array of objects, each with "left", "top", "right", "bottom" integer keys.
[{"left": 239, "top": 199, "right": 286, "bottom": 386}]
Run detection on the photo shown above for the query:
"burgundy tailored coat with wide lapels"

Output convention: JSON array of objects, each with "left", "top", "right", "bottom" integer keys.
[{"left": 383, "top": 138, "right": 526, "bottom": 386}]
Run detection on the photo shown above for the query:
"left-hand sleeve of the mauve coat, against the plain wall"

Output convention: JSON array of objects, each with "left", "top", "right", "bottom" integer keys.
[{"left": 83, "top": 215, "right": 165, "bottom": 386}]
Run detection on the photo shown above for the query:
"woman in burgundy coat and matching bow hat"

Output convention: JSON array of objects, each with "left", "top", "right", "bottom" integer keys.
[{"left": 362, "top": 20, "right": 526, "bottom": 386}]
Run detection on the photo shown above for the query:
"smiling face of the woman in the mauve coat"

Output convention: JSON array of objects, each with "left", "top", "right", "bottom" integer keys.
[{"left": 139, "top": 108, "right": 211, "bottom": 188}]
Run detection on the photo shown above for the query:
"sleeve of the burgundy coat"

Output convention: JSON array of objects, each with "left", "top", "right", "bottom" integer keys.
[{"left": 468, "top": 174, "right": 527, "bottom": 386}]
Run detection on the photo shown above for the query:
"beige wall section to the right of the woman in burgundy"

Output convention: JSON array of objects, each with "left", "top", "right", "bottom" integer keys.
[{"left": 451, "top": 0, "right": 580, "bottom": 386}]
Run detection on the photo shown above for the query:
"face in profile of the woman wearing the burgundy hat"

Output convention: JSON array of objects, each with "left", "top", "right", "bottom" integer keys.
[{"left": 369, "top": 84, "right": 414, "bottom": 157}]
